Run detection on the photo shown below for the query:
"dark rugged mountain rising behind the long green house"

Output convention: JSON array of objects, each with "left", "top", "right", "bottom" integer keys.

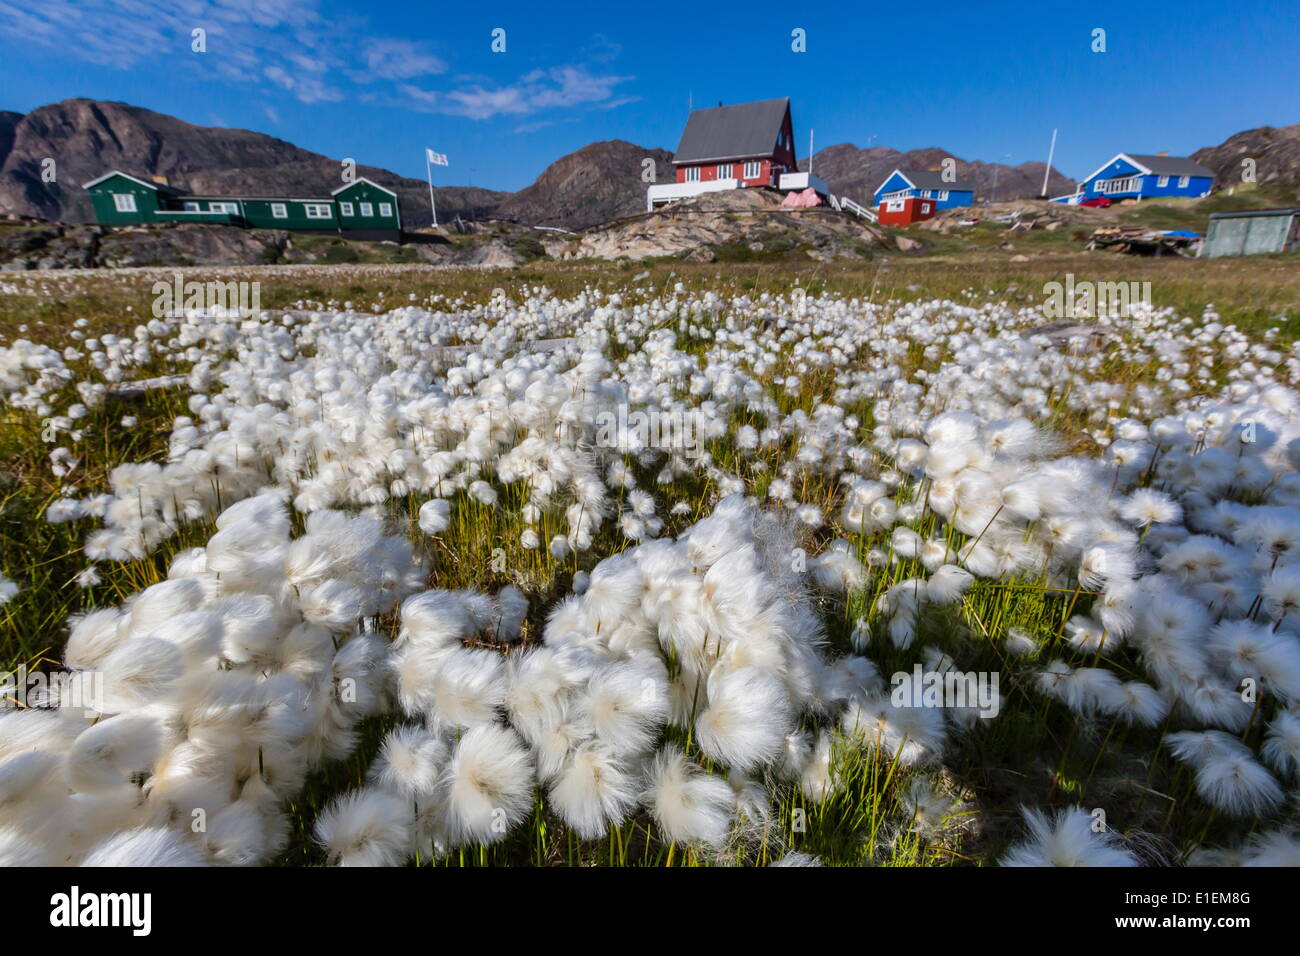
[{"left": 0, "top": 99, "right": 508, "bottom": 228}]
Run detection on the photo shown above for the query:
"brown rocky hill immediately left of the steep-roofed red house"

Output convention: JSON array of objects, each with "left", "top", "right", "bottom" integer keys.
[{"left": 495, "top": 139, "right": 673, "bottom": 229}]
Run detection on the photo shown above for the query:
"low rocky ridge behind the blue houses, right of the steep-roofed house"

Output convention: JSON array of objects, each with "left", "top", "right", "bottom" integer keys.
[{"left": 800, "top": 143, "right": 1074, "bottom": 204}]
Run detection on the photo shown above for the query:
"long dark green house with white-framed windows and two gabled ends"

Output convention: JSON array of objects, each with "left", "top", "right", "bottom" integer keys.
[{"left": 83, "top": 169, "right": 402, "bottom": 239}]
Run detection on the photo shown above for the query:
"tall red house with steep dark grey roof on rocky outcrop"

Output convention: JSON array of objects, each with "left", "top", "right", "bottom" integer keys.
[{"left": 672, "top": 96, "right": 798, "bottom": 186}]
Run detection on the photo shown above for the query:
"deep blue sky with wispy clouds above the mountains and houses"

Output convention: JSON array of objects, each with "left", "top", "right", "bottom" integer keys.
[{"left": 0, "top": 0, "right": 1300, "bottom": 190}]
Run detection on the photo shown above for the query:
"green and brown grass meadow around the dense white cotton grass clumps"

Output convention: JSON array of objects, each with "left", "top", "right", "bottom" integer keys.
[{"left": 0, "top": 252, "right": 1300, "bottom": 866}]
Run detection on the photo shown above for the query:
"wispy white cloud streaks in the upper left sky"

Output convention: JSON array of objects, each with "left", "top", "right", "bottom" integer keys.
[{"left": 0, "top": 0, "right": 632, "bottom": 129}]
